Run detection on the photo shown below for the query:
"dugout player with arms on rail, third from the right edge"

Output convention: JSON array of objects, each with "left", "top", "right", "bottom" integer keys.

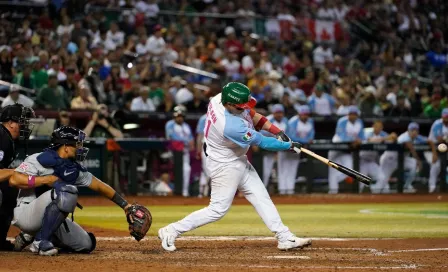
[{"left": 359, "top": 120, "right": 397, "bottom": 192}]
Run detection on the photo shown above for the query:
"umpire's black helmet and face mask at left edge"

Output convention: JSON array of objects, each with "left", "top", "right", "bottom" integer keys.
[{"left": 0, "top": 104, "right": 35, "bottom": 140}]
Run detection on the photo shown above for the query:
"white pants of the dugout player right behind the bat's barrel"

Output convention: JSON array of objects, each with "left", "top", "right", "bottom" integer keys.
[{"left": 328, "top": 150, "right": 353, "bottom": 194}]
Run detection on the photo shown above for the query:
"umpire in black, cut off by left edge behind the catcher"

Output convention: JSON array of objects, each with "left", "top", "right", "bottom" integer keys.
[{"left": 0, "top": 104, "right": 34, "bottom": 251}]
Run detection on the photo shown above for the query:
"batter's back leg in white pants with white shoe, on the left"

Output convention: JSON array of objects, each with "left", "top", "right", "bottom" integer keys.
[{"left": 158, "top": 158, "right": 245, "bottom": 251}]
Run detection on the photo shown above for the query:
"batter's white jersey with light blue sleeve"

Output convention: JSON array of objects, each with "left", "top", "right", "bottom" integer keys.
[{"left": 204, "top": 94, "right": 254, "bottom": 162}]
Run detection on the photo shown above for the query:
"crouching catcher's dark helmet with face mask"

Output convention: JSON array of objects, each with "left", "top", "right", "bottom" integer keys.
[{"left": 48, "top": 126, "right": 89, "bottom": 162}]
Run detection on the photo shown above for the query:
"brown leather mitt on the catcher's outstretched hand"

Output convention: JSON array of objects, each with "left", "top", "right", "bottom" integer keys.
[{"left": 125, "top": 203, "right": 152, "bottom": 241}]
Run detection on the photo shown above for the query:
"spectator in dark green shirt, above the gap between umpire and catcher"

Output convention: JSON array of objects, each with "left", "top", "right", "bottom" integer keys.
[{"left": 36, "top": 72, "right": 70, "bottom": 110}]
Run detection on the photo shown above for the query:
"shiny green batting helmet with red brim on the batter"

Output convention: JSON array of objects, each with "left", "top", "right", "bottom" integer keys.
[{"left": 221, "top": 82, "right": 257, "bottom": 109}]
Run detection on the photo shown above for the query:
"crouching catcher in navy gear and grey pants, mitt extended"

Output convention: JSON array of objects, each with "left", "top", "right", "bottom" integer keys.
[{"left": 9, "top": 127, "right": 152, "bottom": 256}]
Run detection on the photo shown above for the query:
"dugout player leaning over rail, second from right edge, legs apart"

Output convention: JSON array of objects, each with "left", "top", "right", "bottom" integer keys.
[{"left": 372, "top": 122, "right": 437, "bottom": 193}]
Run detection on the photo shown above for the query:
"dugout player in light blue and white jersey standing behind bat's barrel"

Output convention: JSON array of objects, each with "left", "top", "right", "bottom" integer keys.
[{"left": 328, "top": 106, "right": 364, "bottom": 194}]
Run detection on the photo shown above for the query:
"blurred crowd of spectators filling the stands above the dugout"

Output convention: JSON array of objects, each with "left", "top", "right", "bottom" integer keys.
[{"left": 0, "top": 0, "right": 448, "bottom": 196}]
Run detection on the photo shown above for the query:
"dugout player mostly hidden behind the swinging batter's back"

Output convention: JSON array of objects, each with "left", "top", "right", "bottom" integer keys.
[{"left": 196, "top": 114, "right": 210, "bottom": 197}]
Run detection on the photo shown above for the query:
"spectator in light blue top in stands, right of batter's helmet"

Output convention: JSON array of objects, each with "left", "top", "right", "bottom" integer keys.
[{"left": 308, "top": 84, "right": 336, "bottom": 116}]
